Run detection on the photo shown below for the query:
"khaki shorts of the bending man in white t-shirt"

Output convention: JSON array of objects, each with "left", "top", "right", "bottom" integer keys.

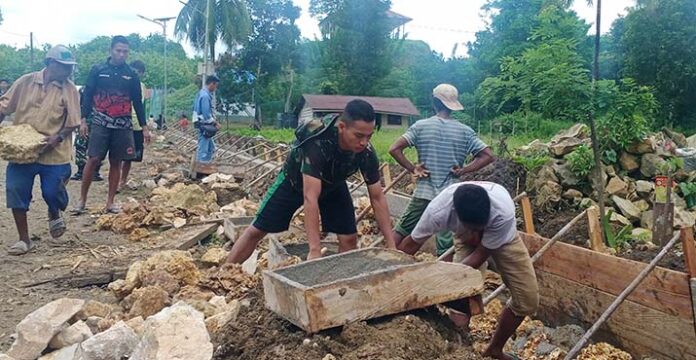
[{"left": 454, "top": 236, "right": 539, "bottom": 316}]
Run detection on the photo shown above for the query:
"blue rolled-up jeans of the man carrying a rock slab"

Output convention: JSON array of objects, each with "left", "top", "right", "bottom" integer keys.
[{"left": 5, "top": 163, "right": 71, "bottom": 213}]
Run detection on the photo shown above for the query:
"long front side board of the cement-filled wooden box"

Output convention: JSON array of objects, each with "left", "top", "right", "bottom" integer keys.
[{"left": 306, "top": 262, "right": 483, "bottom": 332}]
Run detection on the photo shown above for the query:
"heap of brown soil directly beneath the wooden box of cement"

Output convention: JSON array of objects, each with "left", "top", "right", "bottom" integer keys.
[{"left": 213, "top": 286, "right": 481, "bottom": 360}]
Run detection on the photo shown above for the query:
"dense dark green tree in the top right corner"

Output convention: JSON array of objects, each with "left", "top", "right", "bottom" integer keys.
[{"left": 619, "top": 0, "right": 696, "bottom": 126}]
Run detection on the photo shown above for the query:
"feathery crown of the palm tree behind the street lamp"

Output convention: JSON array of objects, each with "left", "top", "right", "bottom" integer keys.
[{"left": 174, "top": 0, "right": 251, "bottom": 61}]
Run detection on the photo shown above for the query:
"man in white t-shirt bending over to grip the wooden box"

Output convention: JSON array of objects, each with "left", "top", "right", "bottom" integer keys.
[{"left": 398, "top": 181, "right": 539, "bottom": 360}]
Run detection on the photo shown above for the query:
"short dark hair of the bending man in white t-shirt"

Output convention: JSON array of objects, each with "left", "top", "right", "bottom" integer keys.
[{"left": 454, "top": 184, "right": 491, "bottom": 225}]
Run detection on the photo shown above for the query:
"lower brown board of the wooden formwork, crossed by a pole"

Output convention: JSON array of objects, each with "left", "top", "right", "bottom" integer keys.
[{"left": 537, "top": 270, "right": 696, "bottom": 360}]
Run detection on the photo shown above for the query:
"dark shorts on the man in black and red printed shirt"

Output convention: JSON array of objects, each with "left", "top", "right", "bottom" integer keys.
[{"left": 87, "top": 124, "right": 135, "bottom": 160}]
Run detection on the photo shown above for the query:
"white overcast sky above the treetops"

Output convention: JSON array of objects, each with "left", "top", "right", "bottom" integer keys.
[{"left": 0, "top": 0, "right": 635, "bottom": 56}]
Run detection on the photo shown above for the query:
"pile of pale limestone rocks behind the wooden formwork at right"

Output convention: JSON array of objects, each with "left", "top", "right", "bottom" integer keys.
[{"left": 518, "top": 124, "right": 696, "bottom": 243}]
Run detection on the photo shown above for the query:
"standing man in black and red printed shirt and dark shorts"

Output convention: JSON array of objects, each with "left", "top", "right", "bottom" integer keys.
[{"left": 74, "top": 36, "right": 150, "bottom": 214}]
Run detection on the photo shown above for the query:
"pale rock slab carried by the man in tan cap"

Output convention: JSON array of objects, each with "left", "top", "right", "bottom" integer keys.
[{"left": 0, "top": 124, "right": 46, "bottom": 164}]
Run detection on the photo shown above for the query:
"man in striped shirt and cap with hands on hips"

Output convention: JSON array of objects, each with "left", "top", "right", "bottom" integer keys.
[{"left": 389, "top": 84, "right": 495, "bottom": 255}]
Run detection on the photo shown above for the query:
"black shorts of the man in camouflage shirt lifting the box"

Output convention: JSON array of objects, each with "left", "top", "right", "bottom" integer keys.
[{"left": 254, "top": 171, "right": 358, "bottom": 235}]
